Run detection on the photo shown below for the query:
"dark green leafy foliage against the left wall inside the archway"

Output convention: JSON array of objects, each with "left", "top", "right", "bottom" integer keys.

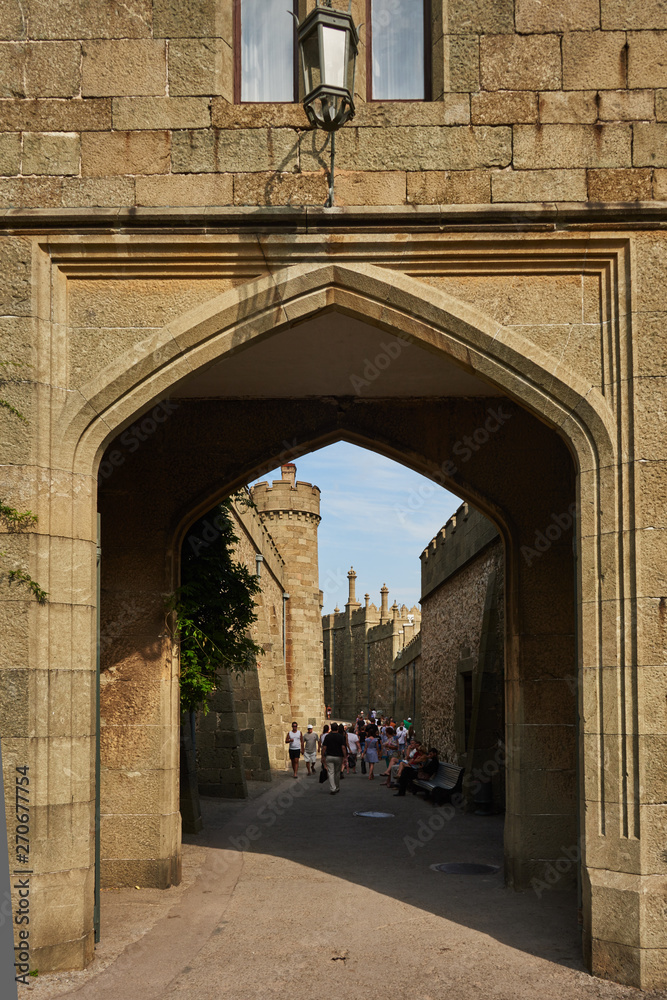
[{"left": 169, "top": 493, "right": 263, "bottom": 712}]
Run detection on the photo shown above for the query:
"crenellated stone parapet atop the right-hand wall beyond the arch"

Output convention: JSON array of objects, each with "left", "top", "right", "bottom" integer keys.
[{"left": 419, "top": 503, "right": 499, "bottom": 600}]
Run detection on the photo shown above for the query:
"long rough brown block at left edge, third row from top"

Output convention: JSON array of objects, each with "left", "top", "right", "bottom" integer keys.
[{"left": 0, "top": 98, "right": 111, "bottom": 132}]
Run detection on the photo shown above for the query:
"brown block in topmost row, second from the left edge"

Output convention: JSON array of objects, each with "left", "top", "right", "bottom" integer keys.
[{"left": 30, "top": 0, "right": 151, "bottom": 38}]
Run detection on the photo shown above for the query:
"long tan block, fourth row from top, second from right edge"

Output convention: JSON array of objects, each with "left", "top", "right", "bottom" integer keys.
[{"left": 514, "top": 125, "right": 632, "bottom": 170}]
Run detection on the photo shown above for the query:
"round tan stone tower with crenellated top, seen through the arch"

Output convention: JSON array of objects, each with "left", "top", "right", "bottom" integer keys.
[{"left": 252, "top": 462, "right": 325, "bottom": 732}]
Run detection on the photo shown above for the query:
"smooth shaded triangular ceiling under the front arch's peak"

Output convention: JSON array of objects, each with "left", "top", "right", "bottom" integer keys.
[{"left": 174, "top": 310, "right": 500, "bottom": 399}]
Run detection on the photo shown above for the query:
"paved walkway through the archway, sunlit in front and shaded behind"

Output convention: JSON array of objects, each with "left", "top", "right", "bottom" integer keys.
[{"left": 34, "top": 770, "right": 647, "bottom": 1000}]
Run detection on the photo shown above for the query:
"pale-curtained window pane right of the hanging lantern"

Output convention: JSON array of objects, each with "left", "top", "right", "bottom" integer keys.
[{"left": 368, "top": 0, "right": 431, "bottom": 101}]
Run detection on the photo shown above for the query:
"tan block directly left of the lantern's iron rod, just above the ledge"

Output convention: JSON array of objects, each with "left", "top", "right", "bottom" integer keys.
[{"left": 234, "top": 171, "right": 330, "bottom": 205}]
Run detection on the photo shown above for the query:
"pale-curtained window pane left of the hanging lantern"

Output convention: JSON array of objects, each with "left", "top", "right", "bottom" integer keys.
[{"left": 234, "top": 0, "right": 297, "bottom": 104}]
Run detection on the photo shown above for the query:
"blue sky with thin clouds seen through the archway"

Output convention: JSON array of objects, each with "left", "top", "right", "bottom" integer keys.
[{"left": 250, "top": 442, "right": 461, "bottom": 614}]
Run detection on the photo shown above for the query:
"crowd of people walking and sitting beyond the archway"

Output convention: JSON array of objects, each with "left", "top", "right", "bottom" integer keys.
[{"left": 285, "top": 712, "right": 438, "bottom": 795}]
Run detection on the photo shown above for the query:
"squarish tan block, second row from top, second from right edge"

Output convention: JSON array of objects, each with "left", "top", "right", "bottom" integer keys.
[{"left": 563, "top": 31, "right": 636, "bottom": 90}]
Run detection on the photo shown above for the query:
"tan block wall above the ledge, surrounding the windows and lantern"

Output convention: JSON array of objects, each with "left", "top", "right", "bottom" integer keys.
[{"left": 0, "top": 0, "right": 667, "bottom": 207}]
